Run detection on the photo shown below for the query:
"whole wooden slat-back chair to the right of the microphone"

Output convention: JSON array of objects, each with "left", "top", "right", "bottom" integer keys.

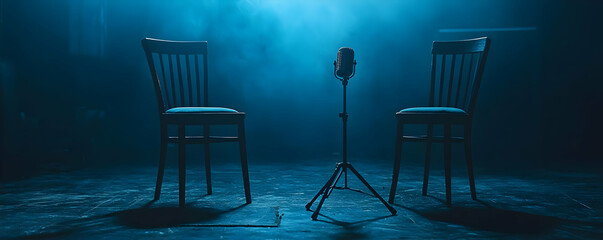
[{"left": 389, "top": 37, "right": 490, "bottom": 205}]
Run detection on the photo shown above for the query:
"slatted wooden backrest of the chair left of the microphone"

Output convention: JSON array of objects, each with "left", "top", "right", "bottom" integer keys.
[{"left": 142, "top": 38, "right": 209, "bottom": 114}]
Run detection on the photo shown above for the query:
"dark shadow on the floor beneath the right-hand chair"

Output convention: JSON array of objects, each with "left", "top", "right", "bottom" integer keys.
[{"left": 394, "top": 195, "right": 563, "bottom": 234}]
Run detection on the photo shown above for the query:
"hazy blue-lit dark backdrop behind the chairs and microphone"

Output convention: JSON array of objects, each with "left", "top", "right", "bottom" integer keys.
[{"left": 0, "top": 0, "right": 603, "bottom": 179}]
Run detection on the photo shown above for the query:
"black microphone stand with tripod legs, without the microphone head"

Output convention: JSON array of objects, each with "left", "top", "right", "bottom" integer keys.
[{"left": 306, "top": 60, "right": 397, "bottom": 220}]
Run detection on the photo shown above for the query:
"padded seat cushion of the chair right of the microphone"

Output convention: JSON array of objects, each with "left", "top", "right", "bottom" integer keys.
[{"left": 396, "top": 107, "right": 469, "bottom": 124}]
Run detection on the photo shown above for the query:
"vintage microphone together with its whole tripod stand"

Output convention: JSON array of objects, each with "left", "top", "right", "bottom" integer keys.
[{"left": 306, "top": 47, "right": 396, "bottom": 220}]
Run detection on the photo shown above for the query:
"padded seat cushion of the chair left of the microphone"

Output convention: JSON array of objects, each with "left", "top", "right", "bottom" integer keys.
[{"left": 161, "top": 107, "right": 245, "bottom": 124}]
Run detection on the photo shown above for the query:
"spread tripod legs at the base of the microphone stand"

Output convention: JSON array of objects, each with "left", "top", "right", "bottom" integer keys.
[{"left": 306, "top": 162, "right": 397, "bottom": 220}]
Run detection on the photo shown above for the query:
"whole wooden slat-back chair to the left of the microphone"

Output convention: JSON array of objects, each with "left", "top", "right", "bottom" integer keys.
[{"left": 142, "top": 38, "right": 251, "bottom": 207}]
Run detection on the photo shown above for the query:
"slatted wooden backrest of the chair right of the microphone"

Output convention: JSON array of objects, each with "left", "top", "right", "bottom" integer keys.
[{"left": 429, "top": 37, "right": 490, "bottom": 115}]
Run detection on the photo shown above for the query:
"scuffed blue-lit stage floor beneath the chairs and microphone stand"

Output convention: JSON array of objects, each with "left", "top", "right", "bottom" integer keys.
[{"left": 0, "top": 159, "right": 603, "bottom": 239}]
